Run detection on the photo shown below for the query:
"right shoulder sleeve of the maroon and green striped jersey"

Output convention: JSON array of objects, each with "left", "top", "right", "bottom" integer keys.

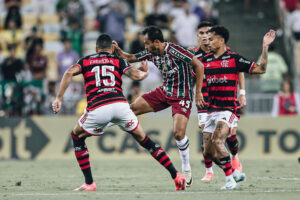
[{"left": 169, "top": 45, "right": 195, "bottom": 64}]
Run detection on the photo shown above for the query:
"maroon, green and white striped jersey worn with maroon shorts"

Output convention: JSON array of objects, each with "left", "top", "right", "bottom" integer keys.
[{"left": 135, "top": 42, "right": 194, "bottom": 100}]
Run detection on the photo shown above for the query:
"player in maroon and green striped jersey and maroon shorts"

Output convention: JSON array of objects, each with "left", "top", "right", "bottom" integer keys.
[{"left": 115, "top": 26, "right": 204, "bottom": 186}]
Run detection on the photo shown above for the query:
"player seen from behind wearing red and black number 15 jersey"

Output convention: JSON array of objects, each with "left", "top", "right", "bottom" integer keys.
[{"left": 52, "top": 34, "right": 185, "bottom": 191}]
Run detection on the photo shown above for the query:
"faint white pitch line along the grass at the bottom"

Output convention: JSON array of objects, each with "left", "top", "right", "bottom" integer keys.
[{"left": 11, "top": 190, "right": 300, "bottom": 196}]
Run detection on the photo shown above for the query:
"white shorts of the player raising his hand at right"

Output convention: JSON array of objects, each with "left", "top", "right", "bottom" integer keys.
[{"left": 203, "top": 111, "right": 239, "bottom": 134}]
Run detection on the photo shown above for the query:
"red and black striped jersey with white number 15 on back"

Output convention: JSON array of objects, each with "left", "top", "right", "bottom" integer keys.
[{"left": 75, "top": 52, "right": 131, "bottom": 111}]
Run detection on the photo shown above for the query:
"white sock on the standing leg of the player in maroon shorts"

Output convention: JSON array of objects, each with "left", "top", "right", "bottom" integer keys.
[{"left": 176, "top": 136, "right": 191, "bottom": 171}]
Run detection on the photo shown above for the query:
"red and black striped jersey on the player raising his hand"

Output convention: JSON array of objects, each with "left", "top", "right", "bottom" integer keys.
[{"left": 201, "top": 50, "right": 255, "bottom": 114}]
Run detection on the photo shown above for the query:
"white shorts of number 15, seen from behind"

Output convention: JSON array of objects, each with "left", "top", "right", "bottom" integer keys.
[{"left": 78, "top": 102, "right": 139, "bottom": 135}]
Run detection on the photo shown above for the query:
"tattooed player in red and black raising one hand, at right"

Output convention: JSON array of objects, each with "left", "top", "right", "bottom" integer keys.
[{"left": 202, "top": 26, "right": 276, "bottom": 189}]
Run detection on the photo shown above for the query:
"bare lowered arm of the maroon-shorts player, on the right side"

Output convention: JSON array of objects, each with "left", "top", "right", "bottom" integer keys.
[{"left": 190, "top": 56, "right": 204, "bottom": 107}]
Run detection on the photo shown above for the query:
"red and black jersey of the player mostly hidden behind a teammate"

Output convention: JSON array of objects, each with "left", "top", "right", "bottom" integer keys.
[{"left": 192, "top": 47, "right": 209, "bottom": 113}]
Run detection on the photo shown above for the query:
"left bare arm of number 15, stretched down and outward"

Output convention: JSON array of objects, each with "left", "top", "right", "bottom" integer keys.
[{"left": 52, "top": 64, "right": 80, "bottom": 114}]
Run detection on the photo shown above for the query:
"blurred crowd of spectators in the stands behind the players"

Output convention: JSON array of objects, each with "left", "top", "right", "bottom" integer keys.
[{"left": 0, "top": 0, "right": 300, "bottom": 116}]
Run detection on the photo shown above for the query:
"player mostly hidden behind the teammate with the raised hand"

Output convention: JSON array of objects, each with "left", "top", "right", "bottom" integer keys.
[{"left": 192, "top": 21, "right": 246, "bottom": 182}]
